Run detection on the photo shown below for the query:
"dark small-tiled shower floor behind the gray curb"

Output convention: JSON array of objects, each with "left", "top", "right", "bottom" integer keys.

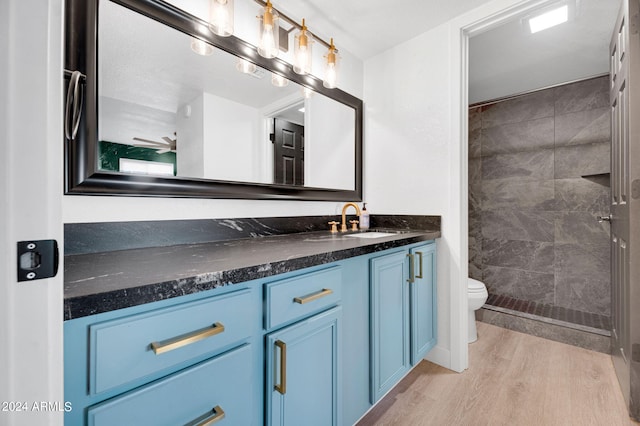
[{"left": 483, "top": 294, "right": 611, "bottom": 336}]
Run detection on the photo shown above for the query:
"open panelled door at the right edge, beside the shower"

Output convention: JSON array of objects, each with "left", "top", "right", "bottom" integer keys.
[{"left": 609, "top": 0, "right": 640, "bottom": 419}]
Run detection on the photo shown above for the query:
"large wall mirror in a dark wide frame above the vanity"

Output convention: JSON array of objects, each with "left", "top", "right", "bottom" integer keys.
[{"left": 65, "top": 0, "right": 363, "bottom": 201}]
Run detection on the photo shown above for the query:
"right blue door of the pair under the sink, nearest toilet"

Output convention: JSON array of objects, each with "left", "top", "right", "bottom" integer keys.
[{"left": 410, "top": 243, "right": 437, "bottom": 365}]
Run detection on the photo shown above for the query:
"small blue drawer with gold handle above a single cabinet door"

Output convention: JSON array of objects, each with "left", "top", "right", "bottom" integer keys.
[{"left": 265, "top": 266, "right": 342, "bottom": 329}]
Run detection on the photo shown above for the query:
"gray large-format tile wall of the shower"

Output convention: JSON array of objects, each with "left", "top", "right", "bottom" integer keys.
[{"left": 469, "top": 76, "right": 611, "bottom": 315}]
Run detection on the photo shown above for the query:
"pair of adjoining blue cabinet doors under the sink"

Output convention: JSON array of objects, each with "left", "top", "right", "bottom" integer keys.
[{"left": 370, "top": 242, "right": 437, "bottom": 404}]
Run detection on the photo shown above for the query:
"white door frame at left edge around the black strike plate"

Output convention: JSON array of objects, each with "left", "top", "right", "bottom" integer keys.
[{"left": 0, "top": 0, "right": 64, "bottom": 426}]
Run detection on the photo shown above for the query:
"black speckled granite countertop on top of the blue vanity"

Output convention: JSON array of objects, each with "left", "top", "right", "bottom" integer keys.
[{"left": 64, "top": 229, "right": 440, "bottom": 320}]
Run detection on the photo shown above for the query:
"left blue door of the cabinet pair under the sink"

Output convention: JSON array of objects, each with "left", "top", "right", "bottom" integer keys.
[{"left": 370, "top": 250, "right": 410, "bottom": 403}]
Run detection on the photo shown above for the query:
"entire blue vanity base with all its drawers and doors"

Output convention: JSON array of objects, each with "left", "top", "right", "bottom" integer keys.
[{"left": 64, "top": 238, "right": 436, "bottom": 426}]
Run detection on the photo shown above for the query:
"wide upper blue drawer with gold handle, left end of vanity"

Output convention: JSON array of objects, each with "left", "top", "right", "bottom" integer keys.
[{"left": 89, "top": 289, "right": 255, "bottom": 394}]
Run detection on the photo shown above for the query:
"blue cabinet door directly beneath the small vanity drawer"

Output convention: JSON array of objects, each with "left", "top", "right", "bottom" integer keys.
[{"left": 266, "top": 307, "right": 342, "bottom": 426}]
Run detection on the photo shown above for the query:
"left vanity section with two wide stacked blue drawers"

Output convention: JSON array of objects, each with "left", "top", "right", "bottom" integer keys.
[{"left": 64, "top": 282, "right": 264, "bottom": 426}]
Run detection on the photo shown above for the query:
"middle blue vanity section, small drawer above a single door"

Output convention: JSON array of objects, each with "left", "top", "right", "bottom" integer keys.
[{"left": 265, "top": 266, "right": 342, "bottom": 426}]
